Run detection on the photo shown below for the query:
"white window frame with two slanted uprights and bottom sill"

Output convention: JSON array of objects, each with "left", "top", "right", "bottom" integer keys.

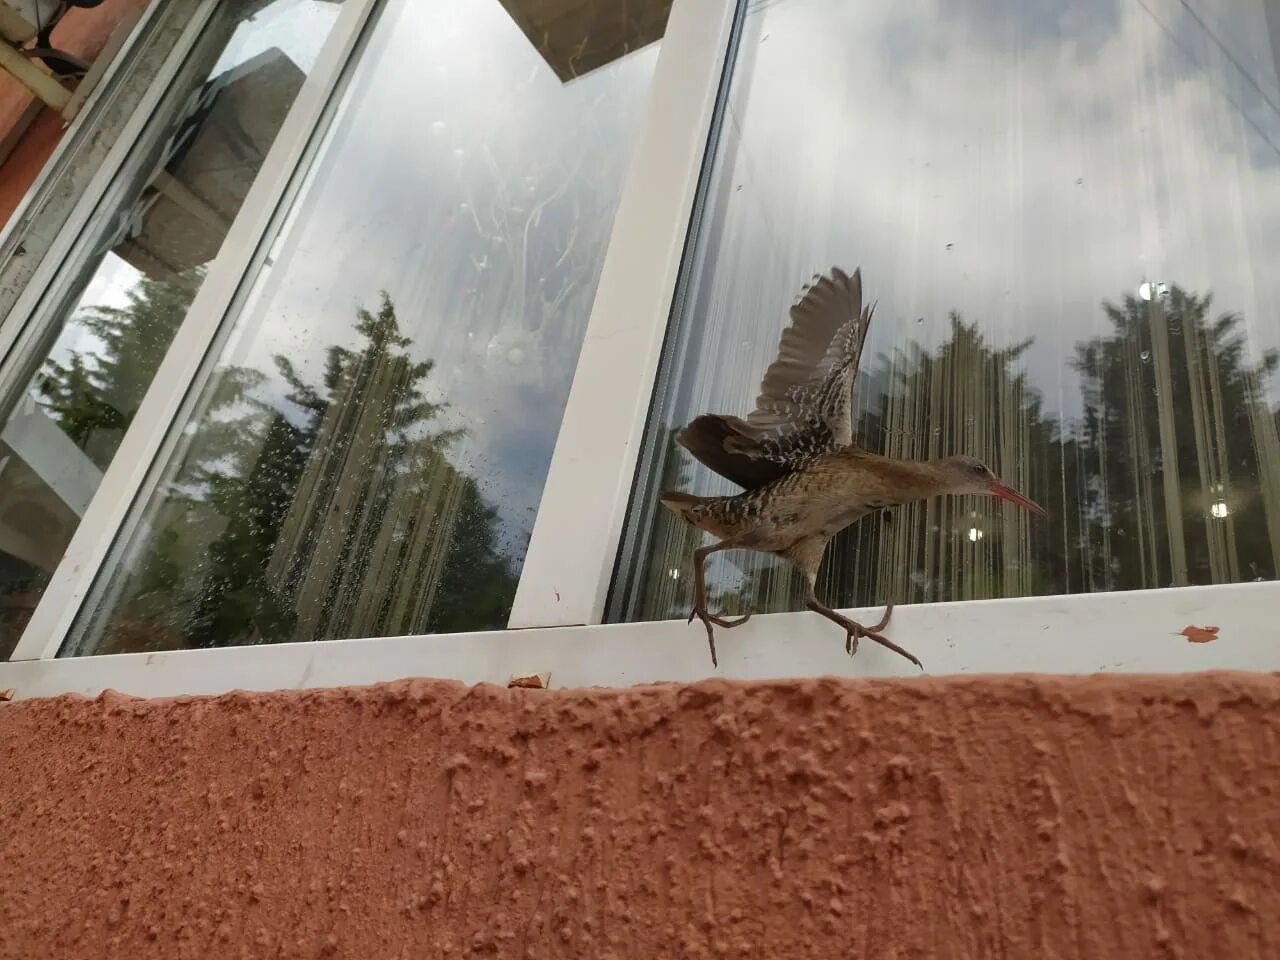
[{"left": 0, "top": 0, "right": 1280, "bottom": 698}]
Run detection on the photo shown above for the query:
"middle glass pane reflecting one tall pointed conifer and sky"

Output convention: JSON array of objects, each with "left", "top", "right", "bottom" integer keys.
[{"left": 68, "top": 0, "right": 666, "bottom": 653}]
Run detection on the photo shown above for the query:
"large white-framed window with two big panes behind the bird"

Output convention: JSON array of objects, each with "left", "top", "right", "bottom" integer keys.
[{"left": 0, "top": 0, "right": 1280, "bottom": 696}]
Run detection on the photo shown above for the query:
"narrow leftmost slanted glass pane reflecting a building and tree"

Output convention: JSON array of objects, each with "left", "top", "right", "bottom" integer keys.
[{"left": 0, "top": 0, "right": 339, "bottom": 657}]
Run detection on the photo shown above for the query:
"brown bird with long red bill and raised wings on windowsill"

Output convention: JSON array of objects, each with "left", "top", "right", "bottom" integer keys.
[{"left": 658, "top": 266, "right": 1044, "bottom": 669}]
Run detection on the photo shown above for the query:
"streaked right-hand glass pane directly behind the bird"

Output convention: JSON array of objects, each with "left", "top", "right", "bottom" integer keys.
[{"left": 611, "top": 0, "right": 1280, "bottom": 620}]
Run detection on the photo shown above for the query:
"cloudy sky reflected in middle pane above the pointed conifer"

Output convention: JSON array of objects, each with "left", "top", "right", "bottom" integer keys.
[{"left": 199, "top": 0, "right": 658, "bottom": 556}]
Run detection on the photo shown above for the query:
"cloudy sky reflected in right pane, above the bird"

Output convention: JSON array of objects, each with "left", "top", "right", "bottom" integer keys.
[{"left": 671, "top": 0, "right": 1280, "bottom": 432}]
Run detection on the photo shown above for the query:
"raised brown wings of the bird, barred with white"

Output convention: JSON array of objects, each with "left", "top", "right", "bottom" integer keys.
[{"left": 676, "top": 268, "right": 874, "bottom": 489}]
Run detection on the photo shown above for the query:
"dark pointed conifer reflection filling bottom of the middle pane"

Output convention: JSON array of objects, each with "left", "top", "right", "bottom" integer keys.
[{"left": 92, "top": 294, "right": 516, "bottom": 649}]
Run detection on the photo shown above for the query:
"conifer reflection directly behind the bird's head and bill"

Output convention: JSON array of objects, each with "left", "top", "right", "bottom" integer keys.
[{"left": 822, "top": 311, "right": 1061, "bottom": 605}]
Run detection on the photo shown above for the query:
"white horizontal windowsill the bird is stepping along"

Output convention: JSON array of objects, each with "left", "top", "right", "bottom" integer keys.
[{"left": 0, "top": 582, "right": 1280, "bottom": 699}]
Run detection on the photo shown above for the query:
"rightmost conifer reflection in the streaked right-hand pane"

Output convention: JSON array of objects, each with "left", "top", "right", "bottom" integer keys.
[{"left": 1073, "top": 287, "right": 1280, "bottom": 589}]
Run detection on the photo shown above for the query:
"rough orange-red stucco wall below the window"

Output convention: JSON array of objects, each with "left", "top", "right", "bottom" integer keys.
[{"left": 0, "top": 675, "right": 1280, "bottom": 960}]
